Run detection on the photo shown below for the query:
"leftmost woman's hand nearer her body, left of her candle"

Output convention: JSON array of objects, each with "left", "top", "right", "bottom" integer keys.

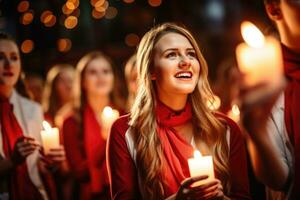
[{"left": 11, "top": 137, "right": 40, "bottom": 165}]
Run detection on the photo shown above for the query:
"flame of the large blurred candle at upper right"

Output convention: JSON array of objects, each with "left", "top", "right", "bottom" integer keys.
[{"left": 241, "top": 21, "right": 265, "bottom": 48}]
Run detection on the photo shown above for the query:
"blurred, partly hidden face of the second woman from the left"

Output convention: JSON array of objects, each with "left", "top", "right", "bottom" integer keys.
[{"left": 55, "top": 70, "right": 74, "bottom": 104}]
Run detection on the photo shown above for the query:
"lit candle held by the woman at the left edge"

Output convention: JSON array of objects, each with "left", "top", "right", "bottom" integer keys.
[{"left": 41, "top": 121, "right": 59, "bottom": 154}]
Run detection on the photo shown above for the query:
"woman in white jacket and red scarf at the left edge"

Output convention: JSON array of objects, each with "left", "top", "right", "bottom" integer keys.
[{"left": 0, "top": 33, "right": 65, "bottom": 200}]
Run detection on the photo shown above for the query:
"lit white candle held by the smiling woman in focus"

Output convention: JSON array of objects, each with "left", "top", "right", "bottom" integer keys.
[{"left": 188, "top": 150, "right": 215, "bottom": 186}]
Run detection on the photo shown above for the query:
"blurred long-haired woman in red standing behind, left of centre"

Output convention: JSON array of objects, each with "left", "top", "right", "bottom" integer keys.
[{"left": 62, "top": 52, "right": 122, "bottom": 200}]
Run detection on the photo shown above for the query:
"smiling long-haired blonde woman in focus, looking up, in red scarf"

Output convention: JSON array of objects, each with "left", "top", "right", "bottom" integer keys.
[{"left": 107, "top": 23, "right": 250, "bottom": 200}]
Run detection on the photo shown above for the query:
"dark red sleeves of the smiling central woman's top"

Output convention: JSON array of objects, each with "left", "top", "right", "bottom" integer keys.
[{"left": 108, "top": 111, "right": 250, "bottom": 200}]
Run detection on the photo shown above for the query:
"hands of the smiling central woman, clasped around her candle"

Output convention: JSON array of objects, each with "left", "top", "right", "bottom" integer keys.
[{"left": 175, "top": 176, "right": 224, "bottom": 200}]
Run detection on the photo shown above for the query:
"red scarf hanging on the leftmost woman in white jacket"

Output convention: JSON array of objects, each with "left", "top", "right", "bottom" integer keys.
[{"left": 0, "top": 98, "right": 43, "bottom": 200}]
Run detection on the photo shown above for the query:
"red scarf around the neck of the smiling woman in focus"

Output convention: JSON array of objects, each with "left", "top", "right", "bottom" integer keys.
[{"left": 156, "top": 101, "right": 194, "bottom": 196}]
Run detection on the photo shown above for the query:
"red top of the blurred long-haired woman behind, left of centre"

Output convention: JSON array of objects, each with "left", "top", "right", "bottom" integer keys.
[{"left": 62, "top": 106, "right": 109, "bottom": 199}]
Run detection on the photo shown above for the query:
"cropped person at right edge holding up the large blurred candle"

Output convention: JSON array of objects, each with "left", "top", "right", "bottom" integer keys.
[{"left": 243, "top": 0, "right": 300, "bottom": 200}]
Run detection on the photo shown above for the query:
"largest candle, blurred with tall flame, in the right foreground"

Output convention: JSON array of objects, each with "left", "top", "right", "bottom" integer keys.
[{"left": 236, "top": 21, "right": 283, "bottom": 104}]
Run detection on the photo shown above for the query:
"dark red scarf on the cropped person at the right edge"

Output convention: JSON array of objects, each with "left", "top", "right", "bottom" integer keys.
[{"left": 282, "top": 45, "right": 300, "bottom": 199}]
